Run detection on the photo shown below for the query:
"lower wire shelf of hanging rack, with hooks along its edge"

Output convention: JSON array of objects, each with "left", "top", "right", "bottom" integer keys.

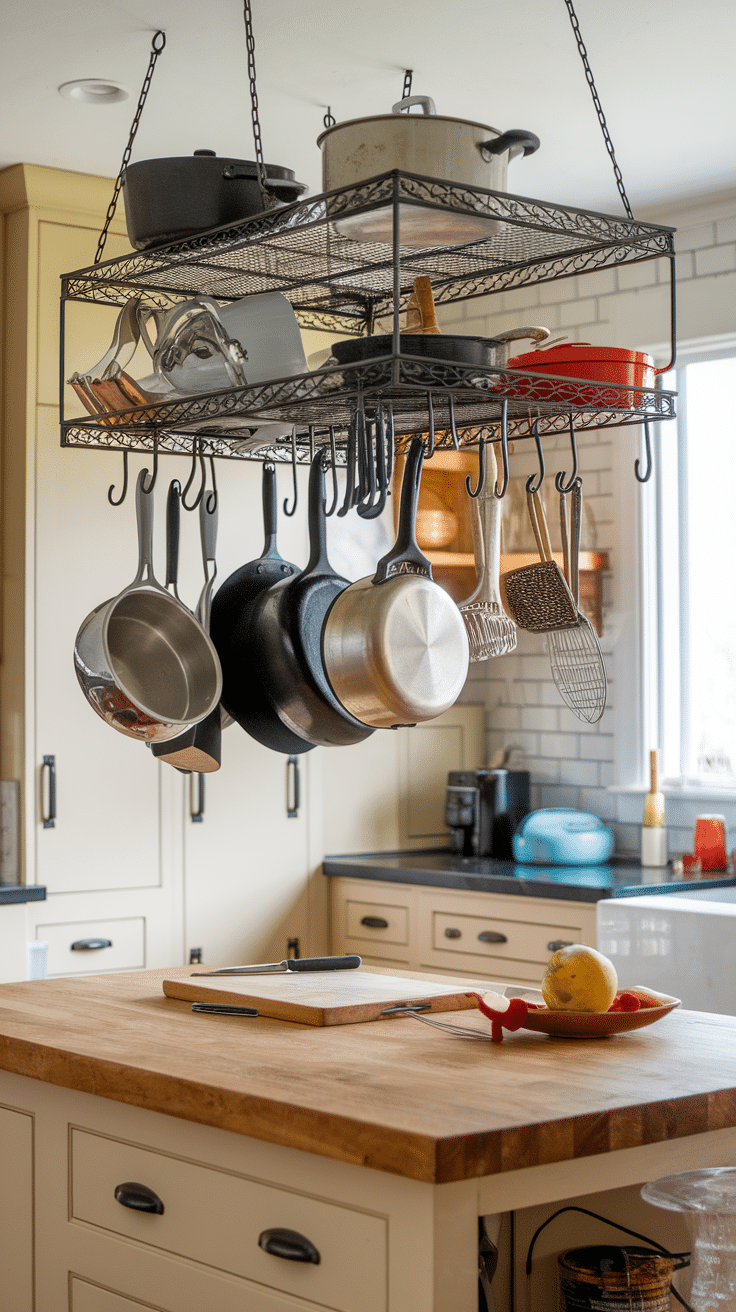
[{"left": 62, "top": 354, "right": 676, "bottom": 463}]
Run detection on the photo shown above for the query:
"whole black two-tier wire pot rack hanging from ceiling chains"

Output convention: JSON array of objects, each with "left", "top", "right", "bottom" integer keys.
[{"left": 60, "top": 0, "right": 676, "bottom": 487}]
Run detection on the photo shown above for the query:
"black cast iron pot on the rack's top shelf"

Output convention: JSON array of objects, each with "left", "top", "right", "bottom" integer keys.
[{"left": 123, "top": 151, "right": 307, "bottom": 251}]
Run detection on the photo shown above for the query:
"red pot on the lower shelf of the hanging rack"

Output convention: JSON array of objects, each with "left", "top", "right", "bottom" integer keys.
[{"left": 508, "top": 342, "right": 656, "bottom": 409}]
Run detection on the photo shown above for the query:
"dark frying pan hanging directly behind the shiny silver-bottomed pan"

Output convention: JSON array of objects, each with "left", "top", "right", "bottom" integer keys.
[{"left": 251, "top": 451, "right": 372, "bottom": 747}]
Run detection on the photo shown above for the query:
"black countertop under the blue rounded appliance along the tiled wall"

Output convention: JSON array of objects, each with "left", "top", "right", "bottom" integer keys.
[{"left": 321, "top": 848, "right": 736, "bottom": 901}]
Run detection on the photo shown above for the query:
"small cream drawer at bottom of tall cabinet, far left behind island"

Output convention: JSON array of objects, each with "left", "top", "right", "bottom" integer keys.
[{"left": 35, "top": 916, "right": 146, "bottom": 975}]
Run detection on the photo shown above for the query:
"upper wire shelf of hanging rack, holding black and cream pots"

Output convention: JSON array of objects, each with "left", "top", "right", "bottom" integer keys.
[{"left": 62, "top": 171, "right": 674, "bottom": 333}]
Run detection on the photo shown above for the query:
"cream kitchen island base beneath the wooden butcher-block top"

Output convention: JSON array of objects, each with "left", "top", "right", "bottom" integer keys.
[{"left": 0, "top": 1072, "right": 736, "bottom": 1312}]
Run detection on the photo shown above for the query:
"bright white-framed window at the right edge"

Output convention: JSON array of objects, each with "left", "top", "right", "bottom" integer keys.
[{"left": 655, "top": 344, "right": 736, "bottom": 790}]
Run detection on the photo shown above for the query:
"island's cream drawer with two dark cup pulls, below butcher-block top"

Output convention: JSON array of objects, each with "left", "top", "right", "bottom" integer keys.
[{"left": 71, "top": 1130, "right": 387, "bottom": 1312}]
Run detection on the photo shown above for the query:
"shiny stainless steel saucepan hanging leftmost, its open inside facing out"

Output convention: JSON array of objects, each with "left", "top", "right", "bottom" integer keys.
[{"left": 75, "top": 470, "right": 222, "bottom": 743}]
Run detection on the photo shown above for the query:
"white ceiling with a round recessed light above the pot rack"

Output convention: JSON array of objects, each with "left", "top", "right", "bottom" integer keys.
[{"left": 0, "top": 0, "right": 736, "bottom": 214}]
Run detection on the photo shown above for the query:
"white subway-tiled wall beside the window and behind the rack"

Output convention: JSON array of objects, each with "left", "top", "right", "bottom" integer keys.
[{"left": 441, "top": 184, "right": 736, "bottom": 851}]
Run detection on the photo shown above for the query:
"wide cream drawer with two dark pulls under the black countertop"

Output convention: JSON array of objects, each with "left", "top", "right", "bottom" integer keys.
[{"left": 432, "top": 912, "right": 580, "bottom": 966}]
